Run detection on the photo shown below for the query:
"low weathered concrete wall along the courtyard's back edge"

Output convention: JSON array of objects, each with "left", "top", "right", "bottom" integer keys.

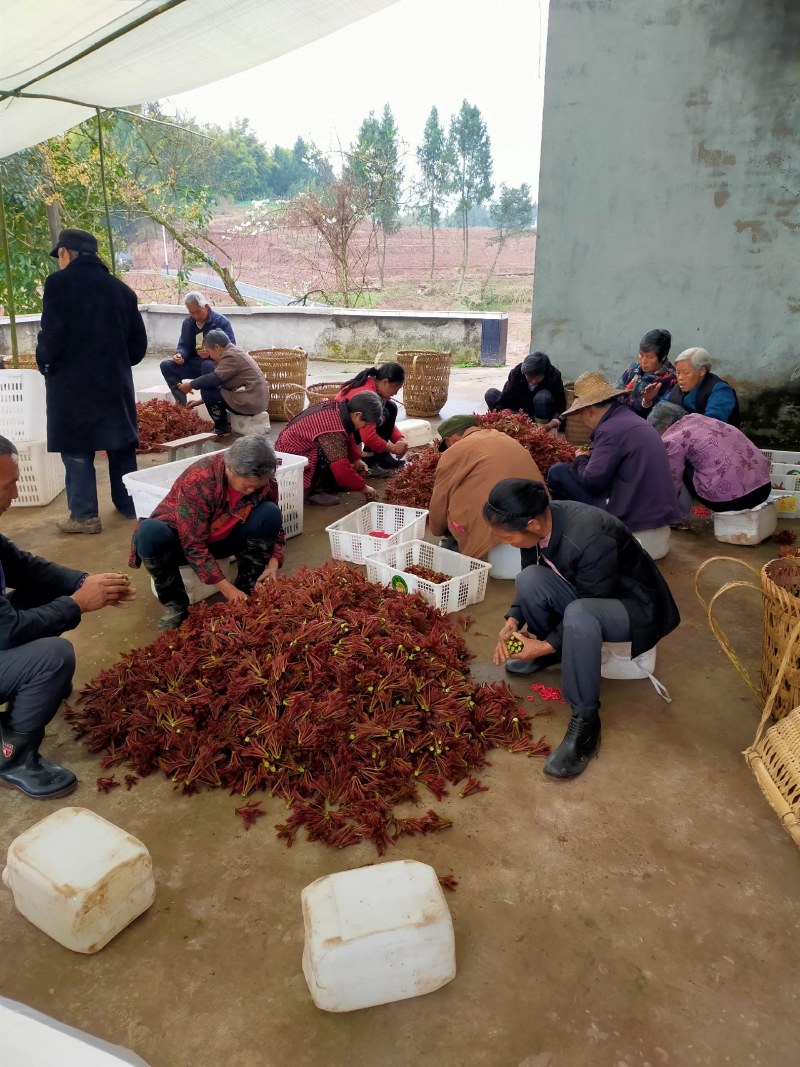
[{"left": 0, "top": 304, "right": 508, "bottom": 364}]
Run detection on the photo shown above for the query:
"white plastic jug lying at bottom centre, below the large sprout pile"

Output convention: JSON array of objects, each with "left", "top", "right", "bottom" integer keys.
[{"left": 301, "top": 860, "right": 455, "bottom": 1012}]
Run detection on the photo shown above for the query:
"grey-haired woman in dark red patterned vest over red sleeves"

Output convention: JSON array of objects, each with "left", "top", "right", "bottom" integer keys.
[{"left": 275, "top": 393, "right": 383, "bottom": 506}]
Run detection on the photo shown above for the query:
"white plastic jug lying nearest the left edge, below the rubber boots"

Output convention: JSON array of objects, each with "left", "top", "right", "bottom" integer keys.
[{"left": 3, "top": 808, "right": 156, "bottom": 953}]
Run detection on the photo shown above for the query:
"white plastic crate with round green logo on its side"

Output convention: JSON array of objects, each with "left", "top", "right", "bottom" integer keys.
[{"left": 367, "top": 541, "right": 492, "bottom": 615}]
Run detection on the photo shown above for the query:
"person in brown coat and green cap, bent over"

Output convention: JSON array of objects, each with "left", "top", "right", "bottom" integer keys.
[{"left": 428, "top": 415, "right": 542, "bottom": 559}]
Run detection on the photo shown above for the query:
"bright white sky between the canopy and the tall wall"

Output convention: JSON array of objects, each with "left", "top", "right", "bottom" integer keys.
[{"left": 165, "top": 0, "right": 547, "bottom": 192}]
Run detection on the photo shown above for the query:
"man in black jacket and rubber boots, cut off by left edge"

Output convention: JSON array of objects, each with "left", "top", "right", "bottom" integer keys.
[{"left": 0, "top": 437, "right": 135, "bottom": 799}]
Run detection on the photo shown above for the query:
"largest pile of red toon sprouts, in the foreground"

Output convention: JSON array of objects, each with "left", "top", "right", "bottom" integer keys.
[{"left": 67, "top": 562, "right": 549, "bottom": 854}]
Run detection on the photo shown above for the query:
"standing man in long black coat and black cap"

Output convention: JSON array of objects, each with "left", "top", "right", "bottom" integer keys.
[{"left": 36, "top": 229, "right": 147, "bottom": 534}]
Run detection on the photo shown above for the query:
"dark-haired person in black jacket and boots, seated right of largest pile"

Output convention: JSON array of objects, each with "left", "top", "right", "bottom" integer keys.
[{"left": 483, "top": 478, "right": 681, "bottom": 778}]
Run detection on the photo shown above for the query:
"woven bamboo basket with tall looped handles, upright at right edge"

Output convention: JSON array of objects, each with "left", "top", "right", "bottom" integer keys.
[{"left": 694, "top": 556, "right": 800, "bottom": 719}]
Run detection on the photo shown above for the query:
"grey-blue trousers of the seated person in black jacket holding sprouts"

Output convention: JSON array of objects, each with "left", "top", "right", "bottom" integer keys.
[{"left": 512, "top": 564, "right": 630, "bottom": 719}]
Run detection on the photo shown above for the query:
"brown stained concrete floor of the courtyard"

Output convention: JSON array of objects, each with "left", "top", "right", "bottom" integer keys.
[{"left": 0, "top": 354, "right": 800, "bottom": 1067}]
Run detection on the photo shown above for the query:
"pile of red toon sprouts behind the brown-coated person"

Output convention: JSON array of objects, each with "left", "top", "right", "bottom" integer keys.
[{"left": 385, "top": 411, "right": 577, "bottom": 508}]
